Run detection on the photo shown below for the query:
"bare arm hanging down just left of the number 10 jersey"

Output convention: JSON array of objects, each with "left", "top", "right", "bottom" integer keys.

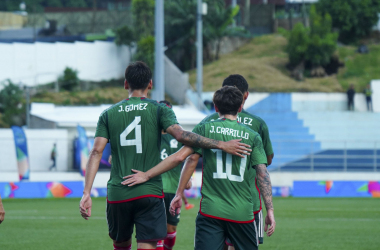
[{"left": 170, "top": 153, "right": 200, "bottom": 215}]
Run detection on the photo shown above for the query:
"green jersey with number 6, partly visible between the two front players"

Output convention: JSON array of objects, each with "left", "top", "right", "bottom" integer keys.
[{"left": 160, "top": 134, "right": 182, "bottom": 194}]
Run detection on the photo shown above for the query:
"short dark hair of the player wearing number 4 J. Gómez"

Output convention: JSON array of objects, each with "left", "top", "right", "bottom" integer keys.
[{"left": 125, "top": 61, "right": 152, "bottom": 90}]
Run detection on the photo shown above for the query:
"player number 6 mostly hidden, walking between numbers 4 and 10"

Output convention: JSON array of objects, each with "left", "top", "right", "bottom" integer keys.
[{"left": 156, "top": 100, "right": 194, "bottom": 250}]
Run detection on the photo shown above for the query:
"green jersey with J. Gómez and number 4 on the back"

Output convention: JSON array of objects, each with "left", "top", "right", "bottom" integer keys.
[{"left": 95, "top": 97, "right": 178, "bottom": 203}]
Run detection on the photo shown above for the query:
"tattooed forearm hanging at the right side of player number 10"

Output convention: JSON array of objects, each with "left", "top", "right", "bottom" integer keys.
[{"left": 255, "top": 164, "right": 273, "bottom": 211}]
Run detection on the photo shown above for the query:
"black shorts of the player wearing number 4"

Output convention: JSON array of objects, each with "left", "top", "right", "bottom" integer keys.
[{"left": 107, "top": 197, "right": 167, "bottom": 242}]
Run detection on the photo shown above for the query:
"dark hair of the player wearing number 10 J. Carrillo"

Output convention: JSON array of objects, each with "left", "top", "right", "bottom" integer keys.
[{"left": 212, "top": 86, "right": 243, "bottom": 115}]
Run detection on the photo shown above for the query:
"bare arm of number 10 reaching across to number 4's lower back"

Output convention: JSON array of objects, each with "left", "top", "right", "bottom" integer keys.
[{"left": 121, "top": 146, "right": 194, "bottom": 186}]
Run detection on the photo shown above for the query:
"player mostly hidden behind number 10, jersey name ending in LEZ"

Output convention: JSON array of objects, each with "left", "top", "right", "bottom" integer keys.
[{"left": 194, "top": 74, "right": 274, "bottom": 250}]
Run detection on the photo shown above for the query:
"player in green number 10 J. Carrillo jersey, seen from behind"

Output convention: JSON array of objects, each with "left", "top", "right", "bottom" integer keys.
[{"left": 123, "top": 86, "right": 276, "bottom": 250}]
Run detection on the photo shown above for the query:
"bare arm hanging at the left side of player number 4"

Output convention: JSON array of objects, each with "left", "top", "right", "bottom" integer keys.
[{"left": 79, "top": 137, "right": 108, "bottom": 220}]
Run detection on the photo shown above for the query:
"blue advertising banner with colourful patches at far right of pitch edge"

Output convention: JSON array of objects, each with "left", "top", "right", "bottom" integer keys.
[{"left": 293, "top": 181, "right": 380, "bottom": 198}]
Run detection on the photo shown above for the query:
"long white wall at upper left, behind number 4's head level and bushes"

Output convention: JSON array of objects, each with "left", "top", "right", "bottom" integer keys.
[{"left": 0, "top": 41, "right": 130, "bottom": 86}]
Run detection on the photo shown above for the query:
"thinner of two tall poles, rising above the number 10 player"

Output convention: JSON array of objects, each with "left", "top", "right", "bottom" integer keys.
[{"left": 197, "top": 0, "right": 203, "bottom": 110}]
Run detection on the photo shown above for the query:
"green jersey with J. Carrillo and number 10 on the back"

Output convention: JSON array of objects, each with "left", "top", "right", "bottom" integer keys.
[{"left": 193, "top": 118, "right": 267, "bottom": 223}]
